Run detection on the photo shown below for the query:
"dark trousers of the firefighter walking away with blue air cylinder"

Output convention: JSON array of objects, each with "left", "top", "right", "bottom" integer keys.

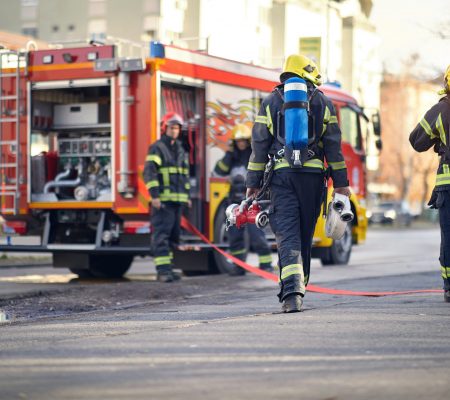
[{"left": 269, "top": 170, "right": 324, "bottom": 302}]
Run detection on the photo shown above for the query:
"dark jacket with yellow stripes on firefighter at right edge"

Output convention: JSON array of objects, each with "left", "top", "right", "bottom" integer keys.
[{"left": 409, "top": 97, "right": 450, "bottom": 190}]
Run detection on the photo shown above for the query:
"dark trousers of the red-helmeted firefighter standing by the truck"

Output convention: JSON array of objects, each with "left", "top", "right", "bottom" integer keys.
[{"left": 150, "top": 203, "right": 183, "bottom": 273}]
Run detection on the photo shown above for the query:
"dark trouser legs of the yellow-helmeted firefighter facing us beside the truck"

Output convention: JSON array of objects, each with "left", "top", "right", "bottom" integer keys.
[{"left": 228, "top": 224, "right": 272, "bottom": 270}]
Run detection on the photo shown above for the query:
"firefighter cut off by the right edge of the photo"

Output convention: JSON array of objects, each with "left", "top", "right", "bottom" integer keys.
[{"left": 409, "top": 65, "right": 450, "bottom": 303}]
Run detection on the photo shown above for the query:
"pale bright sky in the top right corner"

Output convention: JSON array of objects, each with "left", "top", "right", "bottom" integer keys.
[{"left": 371, "top": 0, "right": 450, "bottom": 78}]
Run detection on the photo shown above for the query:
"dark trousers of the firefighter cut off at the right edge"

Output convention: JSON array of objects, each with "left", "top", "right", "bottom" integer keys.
[{"left": 436, "top": 191, "right": 450, "bottom": 290}]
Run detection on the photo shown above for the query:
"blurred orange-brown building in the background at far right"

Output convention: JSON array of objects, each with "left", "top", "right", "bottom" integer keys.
[{"left": 374, "top": 73, "right": 440, "bottom": 212}]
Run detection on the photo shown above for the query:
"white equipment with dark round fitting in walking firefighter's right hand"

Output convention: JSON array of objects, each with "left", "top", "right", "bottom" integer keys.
[{"left": 325, "top": 193, "right": 354, "bottom": 240}]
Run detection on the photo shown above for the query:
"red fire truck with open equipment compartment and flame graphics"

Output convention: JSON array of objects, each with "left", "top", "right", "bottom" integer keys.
[{"left": 0, "top": 42, "right": 378, "bottom": 277}]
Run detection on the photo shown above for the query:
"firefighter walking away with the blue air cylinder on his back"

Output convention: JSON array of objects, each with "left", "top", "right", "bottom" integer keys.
[{"left": 246, "top": 55, "right": 350, "bottom": 312}]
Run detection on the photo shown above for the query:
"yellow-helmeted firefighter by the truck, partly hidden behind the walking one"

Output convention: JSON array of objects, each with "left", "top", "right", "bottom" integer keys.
[{"left": 214, "top": 124, "right": 273, "bottom": 275}]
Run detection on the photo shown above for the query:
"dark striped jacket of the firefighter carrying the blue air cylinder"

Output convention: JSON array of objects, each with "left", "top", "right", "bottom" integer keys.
[{"left": 247, "top": 83, "right": 348, "bottom": 188}]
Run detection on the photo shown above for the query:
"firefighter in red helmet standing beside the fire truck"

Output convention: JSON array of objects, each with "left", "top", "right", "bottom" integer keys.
[{"left": 144, "top": 113, "right": 189, "bottom": 282}]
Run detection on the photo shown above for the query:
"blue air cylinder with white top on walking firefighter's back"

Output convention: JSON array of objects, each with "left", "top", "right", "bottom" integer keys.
[{"left": 284, "top": 78, "right": 308, "bottom": 150}]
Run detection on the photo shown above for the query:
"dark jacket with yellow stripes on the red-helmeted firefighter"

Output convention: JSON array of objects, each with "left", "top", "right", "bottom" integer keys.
[{"left": 144, "top": 135, "right": 190, "bottom": 203}]
